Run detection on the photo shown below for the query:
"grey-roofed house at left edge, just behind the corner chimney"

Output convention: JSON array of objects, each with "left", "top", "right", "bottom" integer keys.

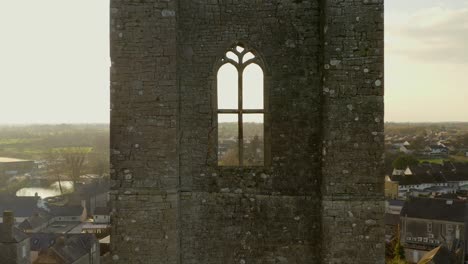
[{"left": 0, "top": 195, "right": 40, "bottom": 223}]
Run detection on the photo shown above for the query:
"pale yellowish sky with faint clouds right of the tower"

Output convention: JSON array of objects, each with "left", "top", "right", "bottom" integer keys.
[{"left": 385, "top": 0, "right": 468, "bottom": 122}]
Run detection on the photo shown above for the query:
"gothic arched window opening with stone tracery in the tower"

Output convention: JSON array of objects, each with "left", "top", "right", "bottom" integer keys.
[{"left": 217, "top": 44, "right": 265, "bottom": 166}]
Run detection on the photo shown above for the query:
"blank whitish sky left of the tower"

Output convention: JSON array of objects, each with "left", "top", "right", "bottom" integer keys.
[{"left": 0, "top": 0, "right": 110, "bottom": 123}]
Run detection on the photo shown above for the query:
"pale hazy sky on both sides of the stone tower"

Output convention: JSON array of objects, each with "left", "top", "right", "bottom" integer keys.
[{"left": 0, "top": 0, "right": 468, "bottom": 123}]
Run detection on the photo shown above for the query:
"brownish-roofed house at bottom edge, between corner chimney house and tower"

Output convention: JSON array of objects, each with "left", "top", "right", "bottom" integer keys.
[{"left": 31, "top": 233, "right": 100, "bottom": 264}]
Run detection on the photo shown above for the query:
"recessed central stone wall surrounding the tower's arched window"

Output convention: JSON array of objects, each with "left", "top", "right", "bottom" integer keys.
[{"left": 177, "top": 0, "right": 321, "bottom": 264}]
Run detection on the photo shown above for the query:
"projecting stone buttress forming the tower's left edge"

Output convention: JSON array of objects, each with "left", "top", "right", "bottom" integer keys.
[{"left": 110, "top": 0, "right": 180, "bottom": 264}]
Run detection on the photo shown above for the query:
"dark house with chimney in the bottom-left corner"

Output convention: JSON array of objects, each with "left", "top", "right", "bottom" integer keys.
[{"left": 0, "top": 211, "right": 31, "bottom": 264}]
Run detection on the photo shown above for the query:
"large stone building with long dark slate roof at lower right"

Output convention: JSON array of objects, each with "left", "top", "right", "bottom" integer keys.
[{"left": 400, "top": 198, "right": 468, "bottom": 263}]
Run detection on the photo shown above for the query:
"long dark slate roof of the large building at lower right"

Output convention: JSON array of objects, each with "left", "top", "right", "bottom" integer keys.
[{"left": 400, "top": 198, "right": 468, "bottom": 223}]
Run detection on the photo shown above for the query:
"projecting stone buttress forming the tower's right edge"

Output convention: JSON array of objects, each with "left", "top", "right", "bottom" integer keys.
[{"left": 321, "top": 0, "right": 385, "bottom": 264}]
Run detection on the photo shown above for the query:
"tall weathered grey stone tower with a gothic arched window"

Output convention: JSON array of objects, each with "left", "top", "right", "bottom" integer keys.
[{"left": 110, "top": 0, "right": 384, "bottom": 264}]
